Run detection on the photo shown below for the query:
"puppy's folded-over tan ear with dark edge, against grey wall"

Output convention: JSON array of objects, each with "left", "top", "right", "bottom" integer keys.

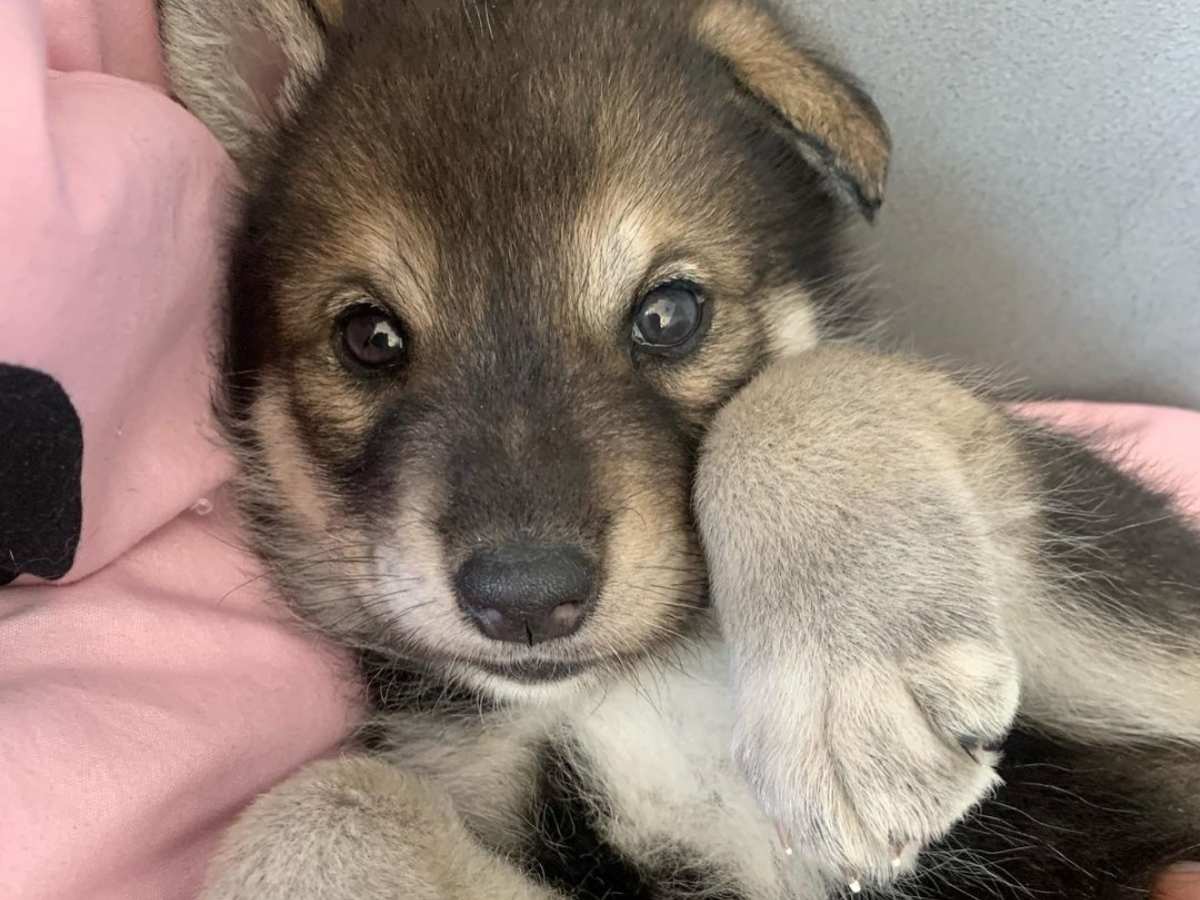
[{"left": 695, "top": 0, "right": 892, "bottom": 220}]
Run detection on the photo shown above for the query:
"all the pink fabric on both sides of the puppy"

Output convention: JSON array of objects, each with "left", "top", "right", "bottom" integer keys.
[{"left": 0, "top": 0, "right": 1200, "bottom": 900}]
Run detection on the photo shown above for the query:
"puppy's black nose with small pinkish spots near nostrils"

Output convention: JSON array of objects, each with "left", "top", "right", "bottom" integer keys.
[{"left": 455, "top": 544, "right": 596, "bottom": 644}]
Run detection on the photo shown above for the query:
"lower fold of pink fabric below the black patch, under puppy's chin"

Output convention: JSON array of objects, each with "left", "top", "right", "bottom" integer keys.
[{"left": 0, "top": 494, "right": 352, "bottom": 900}]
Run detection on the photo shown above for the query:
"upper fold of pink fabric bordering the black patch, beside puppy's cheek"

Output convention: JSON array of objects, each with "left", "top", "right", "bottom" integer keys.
[{"left": 0, "top": 0, "right": 230, "bottom": 581}]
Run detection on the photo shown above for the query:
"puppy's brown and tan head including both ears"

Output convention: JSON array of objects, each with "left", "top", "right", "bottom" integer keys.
[{"left": 162, "top": 0, "right": 888, "bottom": 694}]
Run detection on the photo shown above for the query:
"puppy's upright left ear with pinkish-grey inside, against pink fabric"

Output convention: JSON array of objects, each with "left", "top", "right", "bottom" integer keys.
[{"left": 158, "top": 0, "right": 342, "bottom": 170}]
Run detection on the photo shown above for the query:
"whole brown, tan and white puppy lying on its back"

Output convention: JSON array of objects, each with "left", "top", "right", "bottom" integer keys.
[{"left": 161, "top": 0, "right": 1200, "bottom": 900}]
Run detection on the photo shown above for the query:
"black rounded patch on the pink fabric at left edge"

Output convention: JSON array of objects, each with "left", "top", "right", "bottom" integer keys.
[{"left": 0, "top": 364, "right": 83, "bottom": 584}]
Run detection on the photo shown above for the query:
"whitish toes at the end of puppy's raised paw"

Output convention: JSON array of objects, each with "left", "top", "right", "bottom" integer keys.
[{"left": 734, "top": 641, "right": 1019, "bottom": 890}]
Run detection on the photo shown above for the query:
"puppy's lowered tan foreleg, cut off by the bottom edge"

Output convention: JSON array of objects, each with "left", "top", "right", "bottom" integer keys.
[{"left": 203, "top": 757, "right": 554, "bottom": 900}]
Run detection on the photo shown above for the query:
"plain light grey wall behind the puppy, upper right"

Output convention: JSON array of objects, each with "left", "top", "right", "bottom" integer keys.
[{"left": 787, "top": 0, "right": 1200, "bottom": 408}]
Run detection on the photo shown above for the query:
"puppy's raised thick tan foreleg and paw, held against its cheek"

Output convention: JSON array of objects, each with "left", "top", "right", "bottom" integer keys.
[{"left": 696, "top": 348, "right": 1200, "bottom": 887}]
